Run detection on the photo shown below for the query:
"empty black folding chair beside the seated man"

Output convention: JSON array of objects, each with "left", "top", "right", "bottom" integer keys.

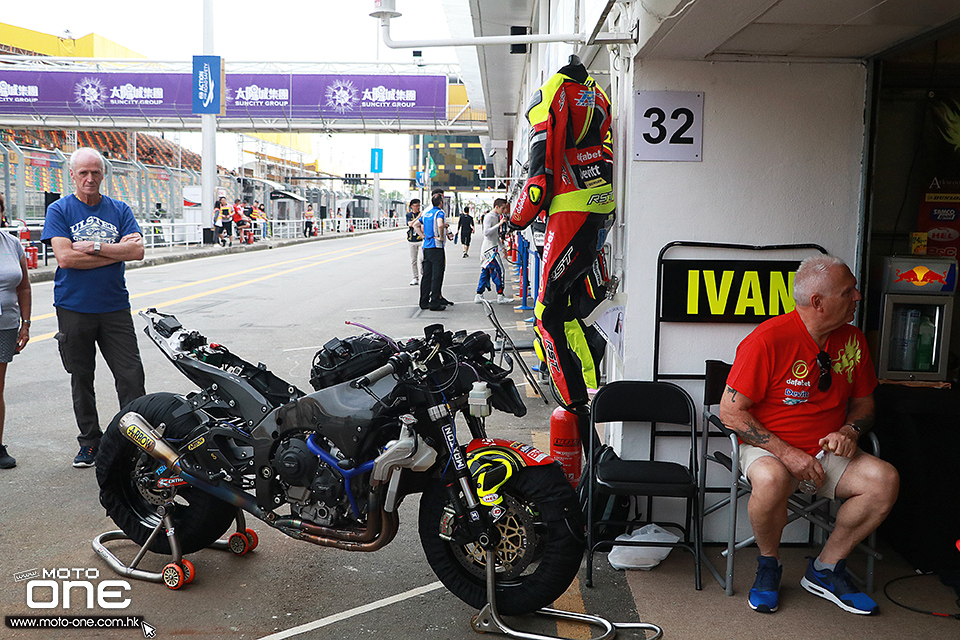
[{"left": 581, "top": 380, "right": 702, "bottom": 589}]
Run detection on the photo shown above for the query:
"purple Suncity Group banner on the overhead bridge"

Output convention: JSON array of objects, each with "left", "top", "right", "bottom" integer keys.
[{"left": 0, "top": 71, "right": 447, "bottom": 120}]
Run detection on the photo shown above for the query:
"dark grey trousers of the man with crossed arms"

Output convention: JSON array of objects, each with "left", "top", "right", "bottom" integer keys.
[{"left": 57, "top": 307, "right": 145, "bottom": 447}]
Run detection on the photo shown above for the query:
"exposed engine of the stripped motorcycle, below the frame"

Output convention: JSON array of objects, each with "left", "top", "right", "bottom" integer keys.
[{"left": 273, "top": 434, "right": 359, "bottom": 527}]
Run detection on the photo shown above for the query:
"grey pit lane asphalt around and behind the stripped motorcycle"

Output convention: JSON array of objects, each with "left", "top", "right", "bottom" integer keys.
[{"left": 0, "top": 231, "right": 637, "bottom": 640}]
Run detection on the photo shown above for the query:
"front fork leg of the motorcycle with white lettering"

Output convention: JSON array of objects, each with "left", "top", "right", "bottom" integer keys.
[{"left": 440, "top": 417, "right": 500, "bottom": 550}]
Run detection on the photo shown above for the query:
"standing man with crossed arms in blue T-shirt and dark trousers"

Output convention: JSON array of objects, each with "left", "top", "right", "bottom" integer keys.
[{"left": 43, "top": 147, "right": 144, "bottom": 467}]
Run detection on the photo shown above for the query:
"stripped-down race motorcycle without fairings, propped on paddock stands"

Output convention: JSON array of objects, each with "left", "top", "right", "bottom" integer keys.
[{"left": 96, "top": 309, "right": 583, "bottom": 615}]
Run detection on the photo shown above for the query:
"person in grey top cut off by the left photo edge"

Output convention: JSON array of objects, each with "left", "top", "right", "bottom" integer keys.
[{"left": 0, "top": 194, "right": 33, "bottom": 469}]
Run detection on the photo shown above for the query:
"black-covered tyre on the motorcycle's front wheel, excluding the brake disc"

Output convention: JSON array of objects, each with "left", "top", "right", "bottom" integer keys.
[{"left": 419, "top": 465, "right": 583, "bottom": 616}]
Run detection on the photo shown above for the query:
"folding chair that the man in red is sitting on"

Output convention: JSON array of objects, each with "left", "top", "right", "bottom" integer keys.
[{"left": 699, "top": 360, "right": 883, "bottom": 596}]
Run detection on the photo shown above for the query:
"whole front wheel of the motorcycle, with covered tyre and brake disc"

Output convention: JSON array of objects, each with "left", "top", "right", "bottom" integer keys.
[{"left": 419, "top": 465, "right": 583, "bottom": 615}]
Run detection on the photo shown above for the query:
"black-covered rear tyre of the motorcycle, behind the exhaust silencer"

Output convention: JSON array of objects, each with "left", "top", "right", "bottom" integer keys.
[{"left": 97, "top": 393, "right": 237, "bottom": 555}]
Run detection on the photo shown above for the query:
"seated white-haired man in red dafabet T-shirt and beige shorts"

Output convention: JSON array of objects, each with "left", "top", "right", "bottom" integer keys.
[{"left": 720, "top": 255, "right": 900, "bottom": 615}]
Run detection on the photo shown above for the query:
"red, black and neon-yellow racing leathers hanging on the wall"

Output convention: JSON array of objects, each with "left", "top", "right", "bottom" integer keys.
[{"left": 510, "top": 64, "right": 615, "bottom": 409}]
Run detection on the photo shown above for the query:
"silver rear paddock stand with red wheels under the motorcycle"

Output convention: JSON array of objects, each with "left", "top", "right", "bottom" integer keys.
[{"left": 91, "top": 503, "right": 259, "bottom": 589}]
